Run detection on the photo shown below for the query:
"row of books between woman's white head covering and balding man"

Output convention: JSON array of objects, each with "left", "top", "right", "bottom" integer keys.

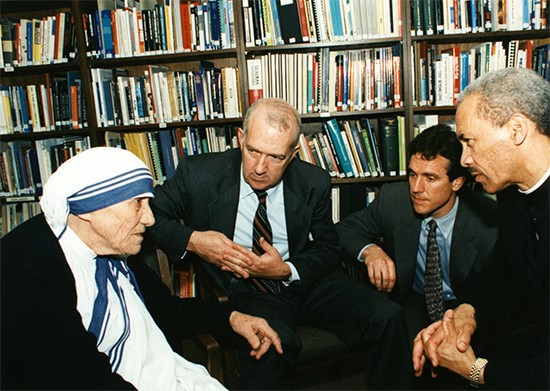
[{"left": 105, "top": 126, "right": 237, "bottom": 184}]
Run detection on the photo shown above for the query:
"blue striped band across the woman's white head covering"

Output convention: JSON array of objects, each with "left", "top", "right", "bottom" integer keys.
[{"left": 68, "top": 168, "right": 154, "bottom": 215}]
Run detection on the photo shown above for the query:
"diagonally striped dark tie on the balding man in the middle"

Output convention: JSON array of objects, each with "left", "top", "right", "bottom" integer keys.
[{"left": 250, "top": 190, "right": 281, "bottom": 294}]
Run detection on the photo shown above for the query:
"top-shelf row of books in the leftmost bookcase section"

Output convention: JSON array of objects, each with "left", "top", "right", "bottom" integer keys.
[{"left": 0, "top": 12, "right": 76, "bottom": 71}]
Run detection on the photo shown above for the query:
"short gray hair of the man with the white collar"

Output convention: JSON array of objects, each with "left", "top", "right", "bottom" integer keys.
[{"left": 458, "top": 68, "right": 550, "bottom": 137}]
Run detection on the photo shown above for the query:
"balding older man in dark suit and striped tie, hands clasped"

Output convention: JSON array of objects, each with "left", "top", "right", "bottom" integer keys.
[{"left": 149, "top": 99, "right": 412, "bottom": 389}]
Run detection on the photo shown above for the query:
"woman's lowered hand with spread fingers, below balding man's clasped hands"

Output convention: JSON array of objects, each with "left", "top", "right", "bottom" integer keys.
[{"left": 229, "top": 311, "right": 283, "bottom": 360}]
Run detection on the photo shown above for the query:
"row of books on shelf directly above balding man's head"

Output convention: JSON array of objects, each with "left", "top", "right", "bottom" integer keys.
[{"left": 247, "top": 45, "right": 402, "bottom": 114}]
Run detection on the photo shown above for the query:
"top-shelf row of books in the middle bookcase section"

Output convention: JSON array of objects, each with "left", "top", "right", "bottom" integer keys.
[{"left": 243, "top": 0, "right": 402, "bottom": 46}]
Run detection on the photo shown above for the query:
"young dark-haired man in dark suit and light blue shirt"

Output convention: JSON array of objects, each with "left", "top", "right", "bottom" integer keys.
[{"left": 336, "top": 125, "right": 497, "bottom": 342}]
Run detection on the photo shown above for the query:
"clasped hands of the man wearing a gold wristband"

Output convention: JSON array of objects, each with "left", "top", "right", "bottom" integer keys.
[{"left": 412, "top": 304, "right": 476, "bottom": 379}]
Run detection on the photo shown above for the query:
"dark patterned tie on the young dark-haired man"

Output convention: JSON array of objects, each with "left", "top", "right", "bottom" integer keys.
[{"left": 424, "top": 220, "right": 445, "bottom": 322}]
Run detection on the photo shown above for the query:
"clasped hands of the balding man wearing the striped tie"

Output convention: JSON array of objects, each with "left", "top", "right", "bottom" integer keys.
[{"left": 187, "top": 231, "right": 291, "bottom": 280}]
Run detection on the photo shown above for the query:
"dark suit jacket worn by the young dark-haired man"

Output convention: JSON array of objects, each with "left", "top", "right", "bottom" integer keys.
[{"left": 336, "top": 182, "right": 498, "bottom": 341}]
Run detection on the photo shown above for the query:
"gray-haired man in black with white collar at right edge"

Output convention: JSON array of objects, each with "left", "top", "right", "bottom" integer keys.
[{"left": 413, "top": 68, "right": 550, "bottom": 390}]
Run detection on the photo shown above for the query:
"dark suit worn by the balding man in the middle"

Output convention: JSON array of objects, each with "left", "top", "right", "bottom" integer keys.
[{"left": 149, "top": 150, "right": 412, "bottom": 389}]
